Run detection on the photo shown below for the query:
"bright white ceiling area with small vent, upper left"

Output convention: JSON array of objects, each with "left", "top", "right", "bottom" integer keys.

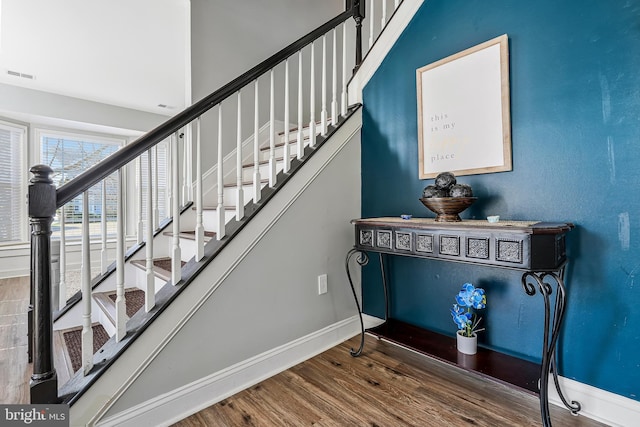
[{"left": 0, "top": 0, "right": 190, "bottom": 115}]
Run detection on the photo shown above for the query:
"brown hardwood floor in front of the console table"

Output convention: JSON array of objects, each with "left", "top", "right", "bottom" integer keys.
[{"left": 175, "top": 336, "right": 603, "bottom": 427}]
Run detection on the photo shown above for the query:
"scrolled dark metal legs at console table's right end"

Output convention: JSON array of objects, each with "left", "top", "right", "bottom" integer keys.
[{"left": 522, "top": 272, "right": 580, "bottom": 427}]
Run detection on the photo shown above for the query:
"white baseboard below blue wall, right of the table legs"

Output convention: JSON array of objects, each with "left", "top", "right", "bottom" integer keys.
[{"left": 549, "top": 375, "right": 640, "bottom": 427}]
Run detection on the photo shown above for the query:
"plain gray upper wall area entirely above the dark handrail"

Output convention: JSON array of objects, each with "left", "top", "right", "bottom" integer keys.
[{"left": 191, "top": 0, "right": 344, "bottom": 101}]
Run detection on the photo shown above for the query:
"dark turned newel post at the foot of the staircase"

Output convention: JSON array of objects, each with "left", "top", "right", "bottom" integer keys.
[{"left": 29, "top": 165, "right": 58, "bottom": 403}]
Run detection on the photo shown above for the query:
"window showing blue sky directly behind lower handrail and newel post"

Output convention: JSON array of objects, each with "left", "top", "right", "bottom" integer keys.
[{"left": 37, "top": 130, "right": 124, "bottom": 239}]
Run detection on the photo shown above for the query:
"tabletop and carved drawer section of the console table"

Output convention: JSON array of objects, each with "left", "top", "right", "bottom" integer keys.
[{"left": 352, "top": 218, "right": 572, "bottom": 270}]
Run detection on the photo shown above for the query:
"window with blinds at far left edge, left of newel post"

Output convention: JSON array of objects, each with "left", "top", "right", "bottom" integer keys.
[{"left": 0, "top": 121, "right": 28, "bottom": 244}]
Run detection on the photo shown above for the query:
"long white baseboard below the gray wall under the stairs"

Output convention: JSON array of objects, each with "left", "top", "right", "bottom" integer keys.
[{"left": 97, "top": 315, "right": 381, "bottom": 427}]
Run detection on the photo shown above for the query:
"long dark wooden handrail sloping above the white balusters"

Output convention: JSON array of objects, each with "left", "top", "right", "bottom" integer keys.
[{"left": 56, "top": 10, "right": 357, "bottom": 208}]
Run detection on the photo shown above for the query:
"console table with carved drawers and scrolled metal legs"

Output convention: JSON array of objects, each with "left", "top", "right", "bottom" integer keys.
[{"left": 345, "top": 217, "right": 580, "bottom": 426}]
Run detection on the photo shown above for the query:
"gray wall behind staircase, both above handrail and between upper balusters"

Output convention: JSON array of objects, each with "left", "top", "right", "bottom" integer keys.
[{"left": 191, "top": 0, "right": 345, "bottom": 176}]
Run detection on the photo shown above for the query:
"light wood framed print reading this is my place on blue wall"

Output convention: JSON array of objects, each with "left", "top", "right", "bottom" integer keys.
[{"left": 416, "top": 34, "right": 512, "bottom": 179}]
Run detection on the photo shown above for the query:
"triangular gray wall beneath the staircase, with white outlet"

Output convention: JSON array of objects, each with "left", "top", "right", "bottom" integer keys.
[{"left": 100, "top": 118, "right": 360, "bottom": 417}]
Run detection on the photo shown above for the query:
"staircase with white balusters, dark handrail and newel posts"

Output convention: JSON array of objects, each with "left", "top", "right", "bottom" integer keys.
[{"left": 29, "top": 1, "right": 417, "bottom": 425}]
